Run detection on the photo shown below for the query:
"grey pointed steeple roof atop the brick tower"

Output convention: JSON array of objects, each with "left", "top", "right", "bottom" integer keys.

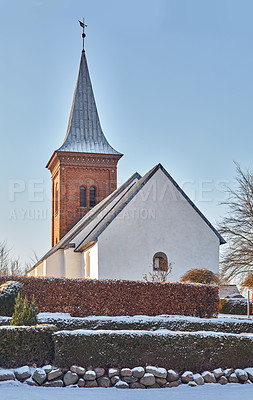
[{"left": 57, "top": 50, "right": 121, "bottom": 155}]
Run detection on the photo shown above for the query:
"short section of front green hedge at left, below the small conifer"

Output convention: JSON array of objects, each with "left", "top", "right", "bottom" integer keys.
[{"left": 0, "top": 325, "right": 57, "bottom": 368}]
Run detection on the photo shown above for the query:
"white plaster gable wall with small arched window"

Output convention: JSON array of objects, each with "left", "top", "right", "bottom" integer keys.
[{"left": 98, "top": 169, "right": 219, "bottom": 281}]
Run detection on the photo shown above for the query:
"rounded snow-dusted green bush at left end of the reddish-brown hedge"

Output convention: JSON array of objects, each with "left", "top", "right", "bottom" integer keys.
[{"left": 0, "top": 281, "right": 23, "bottom": 317}]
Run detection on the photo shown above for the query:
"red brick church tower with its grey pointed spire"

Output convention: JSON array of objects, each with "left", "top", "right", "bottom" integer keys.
[{"left": 46, "top": 50, "right": 122, "bottom": 246}]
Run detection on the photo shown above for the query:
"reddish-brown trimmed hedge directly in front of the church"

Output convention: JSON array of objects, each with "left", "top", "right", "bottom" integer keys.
[{"left": 0, "top": 276, "right": 219, "bottom": 317}]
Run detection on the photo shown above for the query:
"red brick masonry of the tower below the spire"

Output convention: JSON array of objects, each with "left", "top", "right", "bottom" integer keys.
[{"left": 47, "top": 151, "right": 121, "bottom": 246}]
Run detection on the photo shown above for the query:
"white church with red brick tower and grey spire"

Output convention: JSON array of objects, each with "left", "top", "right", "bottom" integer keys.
[{"left": 28, "top": 35, "right": 225, "bottom": 281}]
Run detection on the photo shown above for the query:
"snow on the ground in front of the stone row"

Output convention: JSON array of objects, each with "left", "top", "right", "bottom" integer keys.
[{"left": 0, "top": 382, "right": 253, "bottom": 400}]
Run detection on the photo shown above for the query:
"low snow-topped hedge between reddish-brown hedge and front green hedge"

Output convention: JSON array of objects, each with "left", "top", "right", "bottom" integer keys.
[{"left": 38, "top": 314, "right": 253, "bottom": 334}]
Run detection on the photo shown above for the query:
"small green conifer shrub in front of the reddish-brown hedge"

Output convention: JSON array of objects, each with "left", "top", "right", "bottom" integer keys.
[{"left": 11, "top": 293, "right": 38, "bottom": 326}]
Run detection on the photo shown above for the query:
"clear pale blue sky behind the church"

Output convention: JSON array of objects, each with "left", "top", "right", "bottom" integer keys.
[{"left": 0, "top": 0, "right": 253, "bottom": 266}]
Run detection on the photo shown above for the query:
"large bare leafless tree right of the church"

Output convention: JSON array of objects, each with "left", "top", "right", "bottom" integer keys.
[{"left": 219, "top": 163, "right": 253, "bottom": 283}]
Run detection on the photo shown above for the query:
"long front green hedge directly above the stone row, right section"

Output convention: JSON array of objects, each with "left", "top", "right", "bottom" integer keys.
[{"left": 53, "top": 330, "right": 253, "bottom": 372}]
